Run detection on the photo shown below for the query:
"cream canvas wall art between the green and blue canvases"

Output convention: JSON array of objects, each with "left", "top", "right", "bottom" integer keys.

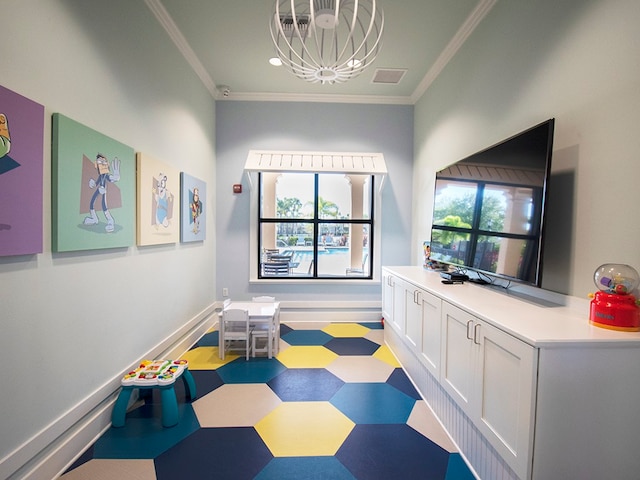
[{"left": 137, "top": 153, "right": 180, "bottom": 246}]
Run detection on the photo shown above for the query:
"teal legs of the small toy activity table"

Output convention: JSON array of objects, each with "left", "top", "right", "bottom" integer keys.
[{"left": 111, "top": 369, "right": 196, "bottom": 427}]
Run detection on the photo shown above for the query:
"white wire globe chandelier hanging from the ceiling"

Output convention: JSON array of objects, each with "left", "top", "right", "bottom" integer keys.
[{"left": 270, "top": 0, "right": 384, "bottom": 84}]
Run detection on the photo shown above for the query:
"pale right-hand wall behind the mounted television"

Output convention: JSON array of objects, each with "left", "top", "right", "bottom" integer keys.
[{"left": 413, "top": 0, "right": 640, "bottom": 298}]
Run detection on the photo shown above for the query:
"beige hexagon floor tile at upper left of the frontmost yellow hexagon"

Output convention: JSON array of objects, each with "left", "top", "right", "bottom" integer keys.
[{"left": 192, "top": 383, "right": 282, "bottom": 428}]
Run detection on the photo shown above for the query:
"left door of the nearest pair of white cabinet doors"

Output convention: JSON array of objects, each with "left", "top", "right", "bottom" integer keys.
[{"left": 440, "top": 302, "right": 477, "bottom": 416}]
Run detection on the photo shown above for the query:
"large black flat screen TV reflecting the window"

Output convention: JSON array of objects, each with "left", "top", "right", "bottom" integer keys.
[{"left": 431, "top": 119, "right": 555, "bottom": 287}]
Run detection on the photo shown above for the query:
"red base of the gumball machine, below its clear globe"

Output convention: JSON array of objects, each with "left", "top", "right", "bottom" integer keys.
[{"left": 589, "top": 291, "right": 640, "bottom": 332}]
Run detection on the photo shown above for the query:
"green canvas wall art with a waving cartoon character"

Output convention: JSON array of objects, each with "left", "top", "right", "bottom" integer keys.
[{"left": 51, "top": 113, "right": 136, "bottom": 252}]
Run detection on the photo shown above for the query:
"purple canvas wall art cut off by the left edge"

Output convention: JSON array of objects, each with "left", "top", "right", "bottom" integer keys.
[{"left": 0, "top": 86, "right": 44, "bottom": 256}]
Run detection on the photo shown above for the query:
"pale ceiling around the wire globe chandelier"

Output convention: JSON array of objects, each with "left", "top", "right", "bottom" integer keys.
[{"left": 145, "top": 0, "right": 497, "bottom": 104}]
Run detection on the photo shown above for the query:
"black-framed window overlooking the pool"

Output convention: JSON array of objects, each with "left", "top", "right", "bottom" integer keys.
[{"left": 256, "top": 172, "right": 375, "bottom": 279}]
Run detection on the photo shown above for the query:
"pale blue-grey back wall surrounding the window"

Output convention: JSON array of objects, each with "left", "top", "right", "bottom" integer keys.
[{"left": 215, "top": 101, "right": 413, "bottom": 301}]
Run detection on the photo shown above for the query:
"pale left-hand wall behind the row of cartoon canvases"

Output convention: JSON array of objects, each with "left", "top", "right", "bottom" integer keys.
[{"left": 0, "top": 0, "right": 216, "bottom": 472}]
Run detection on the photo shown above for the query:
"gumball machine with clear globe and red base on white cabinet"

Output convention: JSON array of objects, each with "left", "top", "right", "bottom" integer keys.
[{"left": 589, "top": 263, "right": 640, "bottom": 332}]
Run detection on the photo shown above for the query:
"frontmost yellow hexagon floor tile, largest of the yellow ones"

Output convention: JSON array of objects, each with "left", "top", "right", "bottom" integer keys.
[{"left": 255, "top": 402, "right": 355, "bottom": 457}]
